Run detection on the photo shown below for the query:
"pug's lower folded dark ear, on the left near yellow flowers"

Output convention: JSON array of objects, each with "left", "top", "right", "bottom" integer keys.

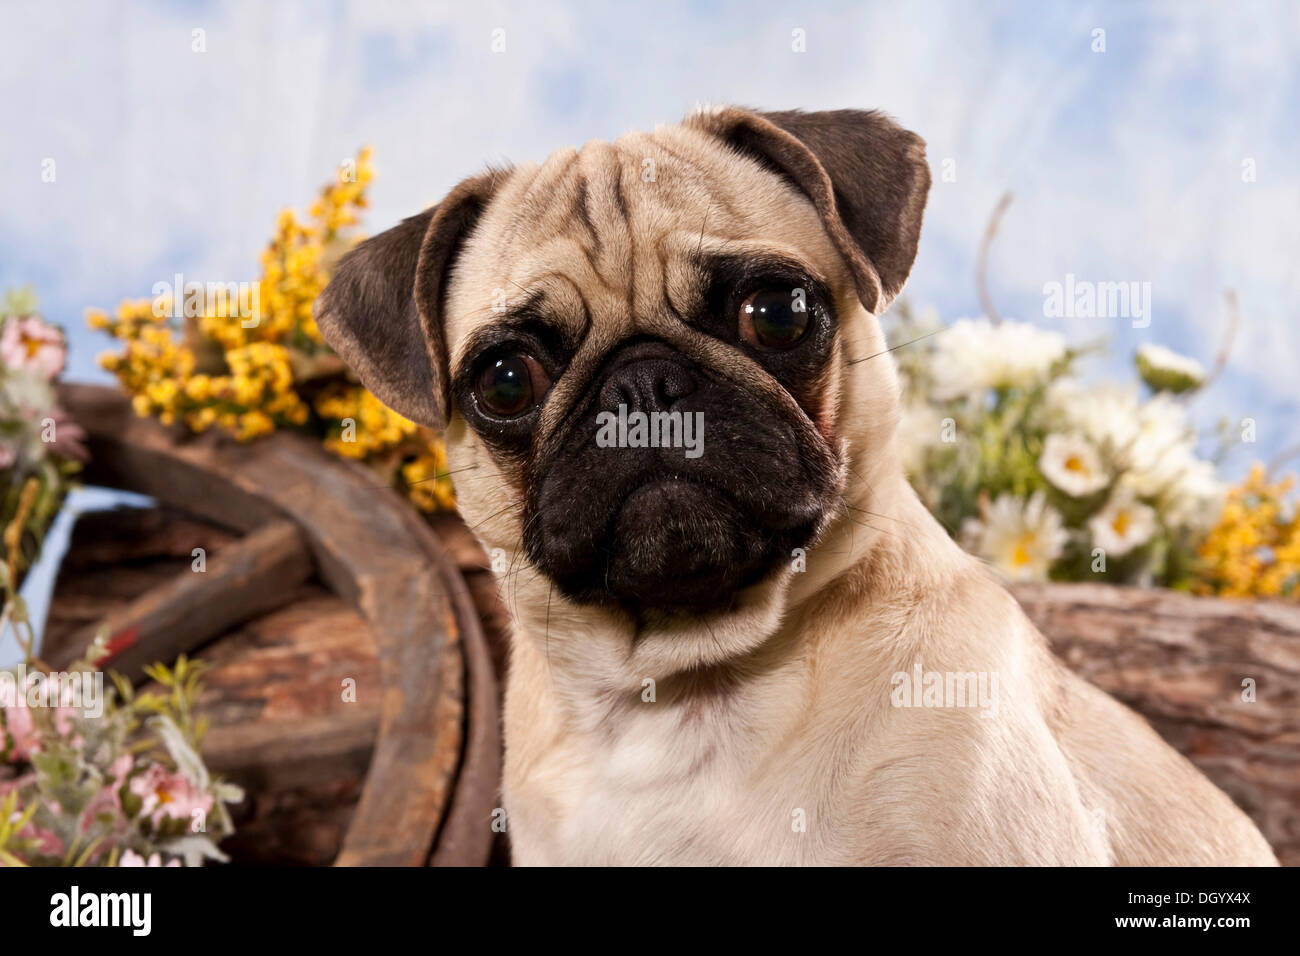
[{"left": 313, "top": 172, "right": 504, "bottom": 429}]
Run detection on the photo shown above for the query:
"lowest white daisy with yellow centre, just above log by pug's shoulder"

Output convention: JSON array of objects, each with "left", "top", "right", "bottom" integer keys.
[{"left": 962, "top": 492, "right": 1070, "bottom": 581}]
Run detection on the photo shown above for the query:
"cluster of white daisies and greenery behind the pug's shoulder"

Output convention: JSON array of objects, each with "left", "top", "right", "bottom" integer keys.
[{"left": 896, "top": 304, "right": 1223, "bottom": 587}]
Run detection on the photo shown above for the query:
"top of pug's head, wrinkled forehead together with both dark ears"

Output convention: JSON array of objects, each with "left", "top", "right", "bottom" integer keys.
[{"left": 313, "top": 108, "right": 930, "bottom": 429}]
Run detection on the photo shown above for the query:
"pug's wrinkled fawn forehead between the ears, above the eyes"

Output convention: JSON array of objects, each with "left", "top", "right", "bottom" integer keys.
[{"left": 446, "top": 126, "right": 848, "bottom": 368}]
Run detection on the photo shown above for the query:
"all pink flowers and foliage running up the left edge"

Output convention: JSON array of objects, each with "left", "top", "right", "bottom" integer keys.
[{"left": 0, "top": 291, "right": 241, "bottom": 866}]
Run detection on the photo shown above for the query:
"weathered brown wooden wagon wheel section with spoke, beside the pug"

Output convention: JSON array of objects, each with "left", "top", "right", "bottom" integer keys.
[{"left": 47, "top": 385, "right": 501, "bottom": 866}]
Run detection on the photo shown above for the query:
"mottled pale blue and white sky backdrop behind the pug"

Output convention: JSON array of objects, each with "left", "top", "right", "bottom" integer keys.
[{"left": 0, "top": 0, "right": 1300, "bottom": 658}]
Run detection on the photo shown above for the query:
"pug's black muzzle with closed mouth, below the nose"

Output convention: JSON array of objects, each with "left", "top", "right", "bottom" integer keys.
[{"left": 524, "top": 343, "right": 836, "bottom": 615}]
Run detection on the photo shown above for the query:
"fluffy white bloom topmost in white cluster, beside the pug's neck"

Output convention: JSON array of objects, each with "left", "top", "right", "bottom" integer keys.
[{"left": 930, "top": 319, "right": 1066, "bottom": 402}]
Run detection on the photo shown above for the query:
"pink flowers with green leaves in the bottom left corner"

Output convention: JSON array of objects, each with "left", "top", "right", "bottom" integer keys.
[{"left": 0, "top": 643, "right": 243, "bottom": 866}]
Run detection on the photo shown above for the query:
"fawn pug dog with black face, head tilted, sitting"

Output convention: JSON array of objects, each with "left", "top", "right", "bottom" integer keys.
[{"left": 316, "top": 108, "right": 1275, "bottom": 865}]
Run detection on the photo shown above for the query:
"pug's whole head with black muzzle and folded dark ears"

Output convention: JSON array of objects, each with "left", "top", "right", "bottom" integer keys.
[{"left": 317, "top": 109, "right": 930, "bottom": 639}]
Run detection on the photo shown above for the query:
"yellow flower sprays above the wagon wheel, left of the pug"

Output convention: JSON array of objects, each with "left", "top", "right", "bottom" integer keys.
[{"left": 86, "top": 147, "right": 455, "bottom": 507}]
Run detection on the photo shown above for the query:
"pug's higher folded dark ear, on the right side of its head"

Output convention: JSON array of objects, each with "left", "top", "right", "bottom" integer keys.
[{"left": 686, "top": 107, "right": 930, "bottom": 312}]
